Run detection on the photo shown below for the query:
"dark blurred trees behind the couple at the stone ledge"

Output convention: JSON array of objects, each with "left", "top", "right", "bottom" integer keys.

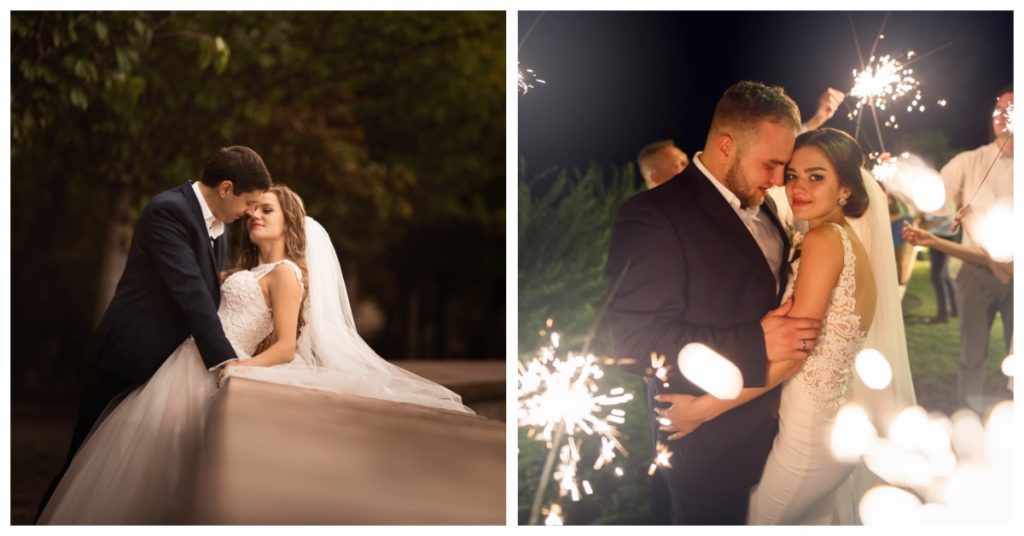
[{"left": 11, "top": 12, "right": 505, "bottom": 394}]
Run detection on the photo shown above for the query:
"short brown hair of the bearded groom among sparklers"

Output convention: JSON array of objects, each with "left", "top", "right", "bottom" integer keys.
[{"left": 711, "top": 80, "right": 800, "bottom": 141}]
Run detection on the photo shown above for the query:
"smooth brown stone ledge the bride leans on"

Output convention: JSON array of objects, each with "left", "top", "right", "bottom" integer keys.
[{"left": 188, "top": 376, "right": 505, "bottom": 525}]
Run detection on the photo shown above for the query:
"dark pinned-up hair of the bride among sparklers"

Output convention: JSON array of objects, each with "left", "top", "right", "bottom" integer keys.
[{"left": 793, "top": 127, "right": 867, "bottom": 217}]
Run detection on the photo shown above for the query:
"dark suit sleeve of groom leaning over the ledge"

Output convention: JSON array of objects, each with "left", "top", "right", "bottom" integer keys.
[{"left": 136, "top": 200, "right": 237, "bottom": 368}]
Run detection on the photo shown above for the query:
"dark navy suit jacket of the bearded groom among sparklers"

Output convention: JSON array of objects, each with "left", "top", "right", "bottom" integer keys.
[{"left": 606, "top": 164, "right": 790, "bottom": 491}]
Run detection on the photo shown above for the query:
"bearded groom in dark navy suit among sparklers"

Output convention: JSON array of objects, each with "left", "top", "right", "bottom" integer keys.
[{"left": 606, "top": 82, "right": 820, "bottom": 525}]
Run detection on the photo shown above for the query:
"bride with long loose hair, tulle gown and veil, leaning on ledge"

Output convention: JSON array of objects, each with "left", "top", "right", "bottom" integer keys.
[{"left": 39, "top": 185, "right": 471, "bottom": 525}]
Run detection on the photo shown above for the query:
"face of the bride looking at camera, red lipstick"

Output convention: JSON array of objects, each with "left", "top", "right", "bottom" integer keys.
[{"left": 785, "top": 146, "right": 850, "bottom": 224}]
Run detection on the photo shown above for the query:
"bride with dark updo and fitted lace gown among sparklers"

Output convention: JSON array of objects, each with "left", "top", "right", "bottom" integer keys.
[{"left": 663, "top": 128, "right": 914, "bottom": 525}]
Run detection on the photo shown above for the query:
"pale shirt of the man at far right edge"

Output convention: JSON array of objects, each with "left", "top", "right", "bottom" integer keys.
[{"left": 941, "top": 141, "right": 1014, "bottom": 252}]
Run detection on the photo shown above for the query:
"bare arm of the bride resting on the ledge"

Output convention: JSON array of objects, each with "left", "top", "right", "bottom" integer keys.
[{"left": 225, "top": 263, "right": 302, "bottom": 373}]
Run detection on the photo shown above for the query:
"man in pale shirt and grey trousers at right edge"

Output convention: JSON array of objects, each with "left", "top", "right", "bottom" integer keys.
[{"left": 941, "top": 86, "right": 1014, "bottom": 413}]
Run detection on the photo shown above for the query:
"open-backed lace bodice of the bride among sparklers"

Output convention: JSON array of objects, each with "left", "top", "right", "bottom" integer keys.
[{"left": 783, "top": 223, "right": 867, "bottom": 411}]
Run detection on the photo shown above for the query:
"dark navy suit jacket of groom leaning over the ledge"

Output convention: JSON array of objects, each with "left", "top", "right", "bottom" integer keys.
[{"left": 86, "top": 182, "right": 236, "bottom": 381}]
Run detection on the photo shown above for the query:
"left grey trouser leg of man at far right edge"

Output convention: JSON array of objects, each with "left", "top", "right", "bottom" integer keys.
[{"left": 956, "top": 262, "right": 999, "bottom": 414}]
